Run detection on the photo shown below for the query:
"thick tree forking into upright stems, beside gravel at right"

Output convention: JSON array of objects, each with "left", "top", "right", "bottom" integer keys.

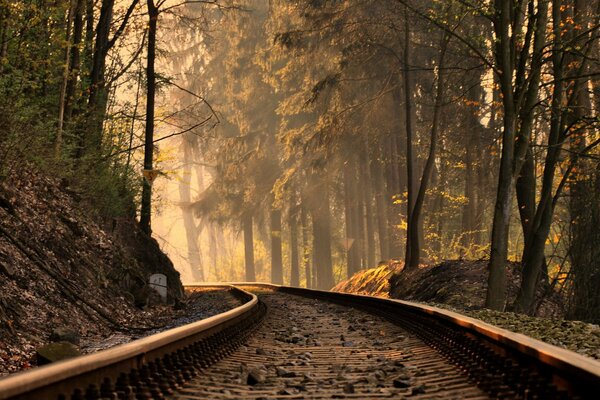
[{"left": 486, "top": 1, "right": 548, "bottom": 310}]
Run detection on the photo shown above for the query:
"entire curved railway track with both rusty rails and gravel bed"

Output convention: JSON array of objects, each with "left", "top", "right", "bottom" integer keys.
[{"left": 0, "top": 284, "right": 600, "bottom": 400}]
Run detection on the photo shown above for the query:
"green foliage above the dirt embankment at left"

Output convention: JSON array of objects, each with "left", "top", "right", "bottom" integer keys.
[{"left": 0, "top": 0, "right": 145, "bottom": 218}]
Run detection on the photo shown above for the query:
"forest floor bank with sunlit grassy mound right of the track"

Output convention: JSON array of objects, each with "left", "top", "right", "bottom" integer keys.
[{"left": 333, "top": 260, "right": 600, "bottom": 359}]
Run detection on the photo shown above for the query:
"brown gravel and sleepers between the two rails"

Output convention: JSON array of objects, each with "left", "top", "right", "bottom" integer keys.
[{"left": 174, "top": 289, "right": 489, "bottom": 400}]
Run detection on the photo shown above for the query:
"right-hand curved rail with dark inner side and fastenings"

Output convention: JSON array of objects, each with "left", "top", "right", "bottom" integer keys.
[{"left": 192, "top": 283, "right": 600, "bottom": 398}]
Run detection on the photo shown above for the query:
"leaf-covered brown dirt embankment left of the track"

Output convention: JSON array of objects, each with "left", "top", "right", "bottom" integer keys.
[{"left": 0, "top": 170, "right": 183, "bottom": 375}]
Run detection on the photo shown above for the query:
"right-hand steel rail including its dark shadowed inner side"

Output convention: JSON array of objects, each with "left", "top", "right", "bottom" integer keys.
[{"left": 186, "top": 282, "right": 600, "bottom": 398}]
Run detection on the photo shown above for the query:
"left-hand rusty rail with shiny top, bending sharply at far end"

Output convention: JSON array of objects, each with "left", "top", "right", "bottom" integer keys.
[{"left": 0, "top": 284, "right": 258, "bottom": 399}]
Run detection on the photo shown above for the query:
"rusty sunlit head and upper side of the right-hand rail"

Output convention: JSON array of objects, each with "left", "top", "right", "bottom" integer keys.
[{"left": 195, "top": 282, "right": 600, "bottom": 394}]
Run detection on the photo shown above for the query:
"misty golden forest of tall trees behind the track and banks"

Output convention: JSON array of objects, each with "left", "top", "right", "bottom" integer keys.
[{"left": 0, "top": 0, "right": 600, "bottom": 320}]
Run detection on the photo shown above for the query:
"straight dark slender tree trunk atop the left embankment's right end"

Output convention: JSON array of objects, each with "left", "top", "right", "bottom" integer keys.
[{"left": 139, "top": 0, "right": 158, "bottom": 235}]
